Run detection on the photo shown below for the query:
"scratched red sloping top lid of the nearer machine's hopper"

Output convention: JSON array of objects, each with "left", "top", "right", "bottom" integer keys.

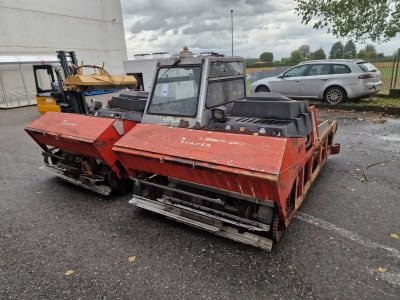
[{"left": 113, "top": 124, "right": 301, "bottom": 177}]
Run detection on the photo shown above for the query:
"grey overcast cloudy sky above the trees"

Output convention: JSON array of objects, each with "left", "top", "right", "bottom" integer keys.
[{"left": 121, "top": 0, "right": 400, "bottom": 59}]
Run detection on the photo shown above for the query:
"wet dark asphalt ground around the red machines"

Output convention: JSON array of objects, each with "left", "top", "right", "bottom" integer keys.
[{"left": 0, "top": 107, "right": 400, "bottom": 299}]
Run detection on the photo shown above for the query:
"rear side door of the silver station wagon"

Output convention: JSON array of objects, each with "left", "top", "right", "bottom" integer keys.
[{"left": 300, "top": 64, "right": 332, "bottom": 98}]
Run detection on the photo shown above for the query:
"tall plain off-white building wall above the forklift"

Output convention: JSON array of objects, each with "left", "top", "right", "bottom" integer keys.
[{"left": 0, "top": 0, "right": 127, "bottom": 73}]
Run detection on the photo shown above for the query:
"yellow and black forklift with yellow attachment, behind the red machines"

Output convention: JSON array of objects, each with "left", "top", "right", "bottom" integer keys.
[{"left": 33, "top": 51, "right": 137, "bottom": 114}]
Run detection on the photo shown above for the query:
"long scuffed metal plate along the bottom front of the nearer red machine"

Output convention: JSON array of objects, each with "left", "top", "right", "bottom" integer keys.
[{"left": 129, "top": 195, "right": 273, "bottom": 251}]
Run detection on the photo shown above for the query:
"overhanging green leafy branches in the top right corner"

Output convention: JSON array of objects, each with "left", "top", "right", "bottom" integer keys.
[{"left": 295, "top": 0, "right": 400, "bottom": 42}]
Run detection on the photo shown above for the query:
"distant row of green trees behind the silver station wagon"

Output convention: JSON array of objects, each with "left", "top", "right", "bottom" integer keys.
[{"left": 253, "top": 40, "right": 384, "bottom": 65}]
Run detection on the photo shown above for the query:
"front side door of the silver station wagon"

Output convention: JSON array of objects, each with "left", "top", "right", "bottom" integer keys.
[{"left": 269, "top": 65, "right": 308, "bottom": 97}]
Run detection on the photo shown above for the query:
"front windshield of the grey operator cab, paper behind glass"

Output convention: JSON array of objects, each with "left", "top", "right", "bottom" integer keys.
[{"left": 147, "top": 66, "right": 201, "bottom": 117}]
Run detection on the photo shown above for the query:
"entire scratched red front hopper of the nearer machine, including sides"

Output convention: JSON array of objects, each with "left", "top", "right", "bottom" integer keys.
[{"left": 113, "top": 124, "right": 305, "bottom": 217}]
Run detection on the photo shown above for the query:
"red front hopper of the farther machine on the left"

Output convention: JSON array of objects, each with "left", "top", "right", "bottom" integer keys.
[{"left": 25, "top": 112, "right": 136, "bottom": 175}]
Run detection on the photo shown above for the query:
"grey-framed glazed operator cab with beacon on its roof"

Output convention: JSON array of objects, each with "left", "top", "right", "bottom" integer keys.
[{"left": 142, "top": 47, "right": 246, "bottom": 127}]
